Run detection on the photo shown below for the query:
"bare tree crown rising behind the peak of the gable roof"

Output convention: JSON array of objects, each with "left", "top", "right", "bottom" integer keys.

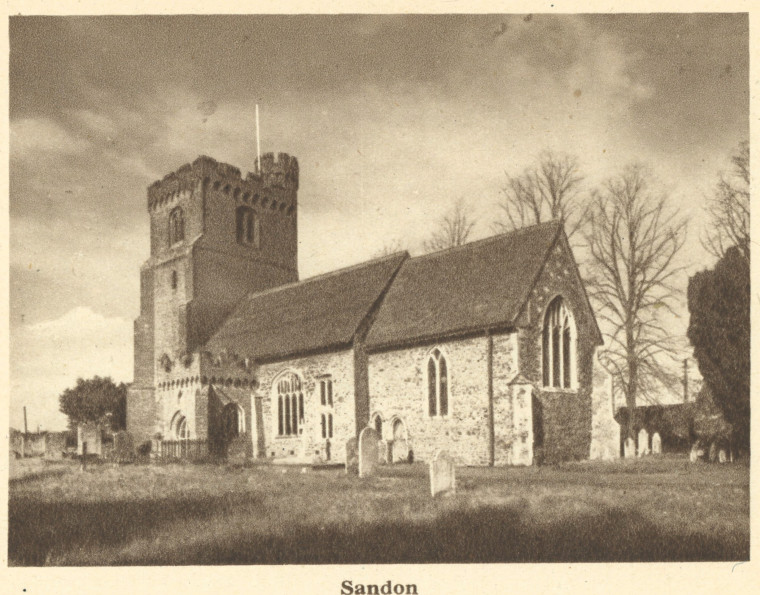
[{"left": 495, "top": 150, "right": 589, "bottom": 238}]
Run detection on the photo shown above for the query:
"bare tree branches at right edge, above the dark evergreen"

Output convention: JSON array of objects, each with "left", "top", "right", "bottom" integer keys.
[{"left": 702, "top": 141, "right": 749, "bottom": 260}]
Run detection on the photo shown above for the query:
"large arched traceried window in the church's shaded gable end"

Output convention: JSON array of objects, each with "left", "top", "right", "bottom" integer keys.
[{"left": 541, "top": 297, "right": 576, "bottom": 388}]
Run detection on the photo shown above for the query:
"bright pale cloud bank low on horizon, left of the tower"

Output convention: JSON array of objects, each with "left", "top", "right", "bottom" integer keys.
[{"left": 10, "top": 307, "right": 132, "bottom": 430}]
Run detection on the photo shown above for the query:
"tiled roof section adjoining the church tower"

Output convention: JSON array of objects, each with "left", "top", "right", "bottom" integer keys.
[{"left": 200, "top": 252, "right": 409, "bottom": 361}]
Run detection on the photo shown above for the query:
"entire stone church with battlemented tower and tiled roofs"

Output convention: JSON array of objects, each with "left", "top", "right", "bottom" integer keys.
[{"left": 127, "top": 153, "right": 617, "bottom": 465}]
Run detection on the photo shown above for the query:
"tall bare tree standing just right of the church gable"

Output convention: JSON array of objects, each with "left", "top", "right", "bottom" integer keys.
[{"left": 586, "top": 165, "right": 686, "bottom": 438}]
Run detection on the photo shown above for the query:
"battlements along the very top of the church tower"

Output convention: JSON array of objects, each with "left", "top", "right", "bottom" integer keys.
[{"left": 148, "top": 153, "right": 299, "bottom": 211}]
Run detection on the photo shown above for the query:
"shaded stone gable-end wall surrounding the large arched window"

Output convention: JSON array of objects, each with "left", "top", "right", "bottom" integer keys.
[{"left": 519, "top": 238, "right": 596, "bottom": 462}]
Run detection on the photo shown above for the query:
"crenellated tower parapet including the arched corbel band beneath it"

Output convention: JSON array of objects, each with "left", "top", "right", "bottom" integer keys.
[{"left": 148, "top": 153, "right": 299, "bottom": 215}]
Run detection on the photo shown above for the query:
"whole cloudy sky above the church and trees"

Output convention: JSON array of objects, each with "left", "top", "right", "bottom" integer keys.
[{"left": 9, "top": 14, "right": 749, "bottom": 430}]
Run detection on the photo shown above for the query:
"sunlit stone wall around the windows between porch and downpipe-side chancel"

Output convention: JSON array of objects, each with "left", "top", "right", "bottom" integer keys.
[{"left": 253, "top": 349, "right": 356, "bottom": 462}]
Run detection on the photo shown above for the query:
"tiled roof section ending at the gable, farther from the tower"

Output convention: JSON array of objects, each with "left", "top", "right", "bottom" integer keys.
[{"left": 367, "top": 221, "right": 562, "bottom": 349}]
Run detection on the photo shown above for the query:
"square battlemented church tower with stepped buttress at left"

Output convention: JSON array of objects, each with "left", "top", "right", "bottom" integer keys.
[{"left": 127, "top": 153, "right": 298, "bottom": 441}]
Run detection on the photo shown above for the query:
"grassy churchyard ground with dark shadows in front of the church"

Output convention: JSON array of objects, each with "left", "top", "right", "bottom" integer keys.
[{"left": 8, "top": 456, "right": 749, "bottom": 566}]
